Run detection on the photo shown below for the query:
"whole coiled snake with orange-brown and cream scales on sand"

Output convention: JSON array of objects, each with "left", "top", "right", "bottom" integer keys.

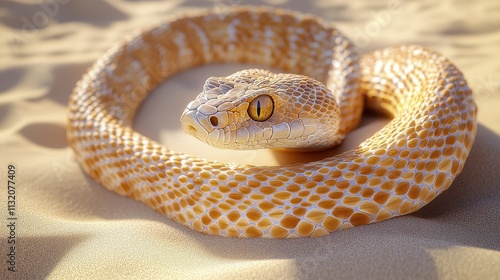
[{"left": 67, "top": 6, "right": 477, "bottom": 238}]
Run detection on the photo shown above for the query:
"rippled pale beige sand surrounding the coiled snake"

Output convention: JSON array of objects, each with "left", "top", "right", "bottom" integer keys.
[{"left": 0, "top": 0, "right": 500, "bottom": 279}]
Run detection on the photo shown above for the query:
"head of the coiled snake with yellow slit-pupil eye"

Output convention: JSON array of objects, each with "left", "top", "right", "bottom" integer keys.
[{"left": 181, "top": 69, "right": 339, "bottom": 150}]
